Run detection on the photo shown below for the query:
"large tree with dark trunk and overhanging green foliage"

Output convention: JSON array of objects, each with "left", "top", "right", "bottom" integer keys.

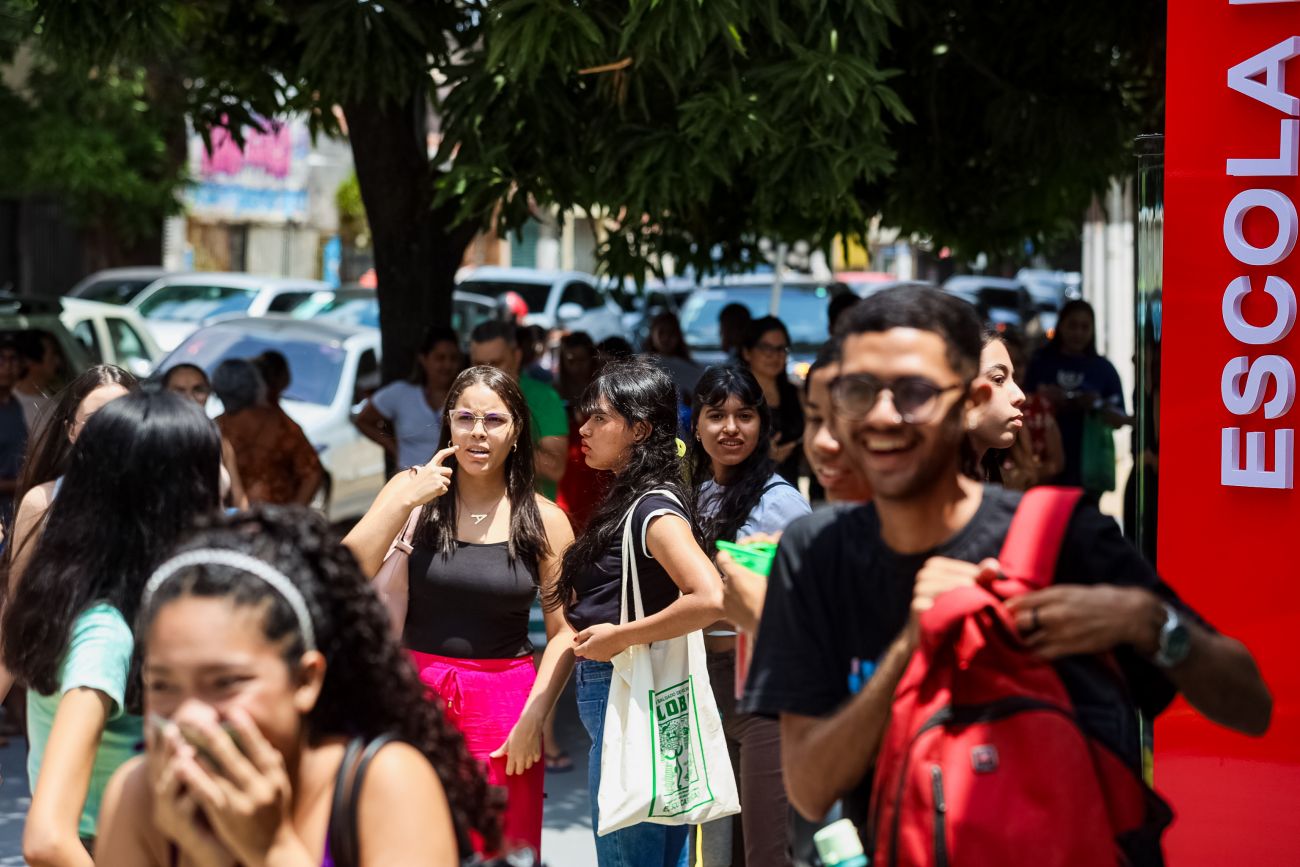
[{"left": 17, "top": 0, "right": 1164, "bottom": 378}]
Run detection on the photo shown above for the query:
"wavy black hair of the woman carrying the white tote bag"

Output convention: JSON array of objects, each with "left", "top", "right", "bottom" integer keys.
[{"left": 542, "top": 357, "right": 694, "bottom": 611}]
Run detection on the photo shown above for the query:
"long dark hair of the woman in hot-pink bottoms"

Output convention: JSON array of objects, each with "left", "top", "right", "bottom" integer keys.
[{"left": 415, "top": 364, "right": 550, "bottom": 571}]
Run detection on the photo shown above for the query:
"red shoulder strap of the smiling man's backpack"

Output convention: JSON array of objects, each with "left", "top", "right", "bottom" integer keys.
[{"left": 995, "top": 487, "right": 1083, "bottom": 598}]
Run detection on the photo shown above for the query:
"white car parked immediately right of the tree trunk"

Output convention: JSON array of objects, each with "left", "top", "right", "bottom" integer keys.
[{"left": 456, "top": 266, "right": 624, "bottom": 342}]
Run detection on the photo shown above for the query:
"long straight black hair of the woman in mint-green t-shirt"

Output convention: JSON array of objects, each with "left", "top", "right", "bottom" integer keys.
[{"left": 3, "top": 391, "right": 221, "bottom": 695}]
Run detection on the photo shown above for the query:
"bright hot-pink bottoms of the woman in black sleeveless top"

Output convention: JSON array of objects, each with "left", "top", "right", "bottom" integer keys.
[{"left": 407, "top": 650, "right": 546, "bottom": 861}]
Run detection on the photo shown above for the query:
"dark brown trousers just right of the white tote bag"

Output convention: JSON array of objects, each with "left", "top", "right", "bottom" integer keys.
[{"left": 692, "top": 651, "right": 792, "bottom": 867}]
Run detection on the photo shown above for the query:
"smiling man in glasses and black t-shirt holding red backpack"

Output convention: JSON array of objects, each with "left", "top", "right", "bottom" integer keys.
[{"left": 724, "top": 289, "right": 1271, "bottom": 866}]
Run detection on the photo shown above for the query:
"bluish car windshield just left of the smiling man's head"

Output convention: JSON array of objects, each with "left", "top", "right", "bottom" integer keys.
[{"left": 681, "top": 286, "right": 829, "bottom": 350}]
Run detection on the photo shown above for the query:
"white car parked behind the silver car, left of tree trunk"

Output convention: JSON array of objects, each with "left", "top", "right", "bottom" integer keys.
[{"left": 130, "top": 272, "right": 334, "bottom": 351}]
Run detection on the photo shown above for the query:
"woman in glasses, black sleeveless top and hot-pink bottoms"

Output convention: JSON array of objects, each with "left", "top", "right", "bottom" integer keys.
[{"left": 343, "top": 367, "right": 573, "bottom": 853}]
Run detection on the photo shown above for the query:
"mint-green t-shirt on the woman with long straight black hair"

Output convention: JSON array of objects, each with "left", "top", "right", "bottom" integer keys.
[{"left": 27, "top": 603, "right": 144, "bottom": 837}]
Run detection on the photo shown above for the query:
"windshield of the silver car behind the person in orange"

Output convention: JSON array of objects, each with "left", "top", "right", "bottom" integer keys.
[{"left": 159, "top": 328, "right": 347, "bottom": 407}]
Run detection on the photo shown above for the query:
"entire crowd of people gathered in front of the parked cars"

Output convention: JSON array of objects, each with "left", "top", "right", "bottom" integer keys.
[{"left": 0, "top": 289, "right": 1271, "bottom": 867}]
